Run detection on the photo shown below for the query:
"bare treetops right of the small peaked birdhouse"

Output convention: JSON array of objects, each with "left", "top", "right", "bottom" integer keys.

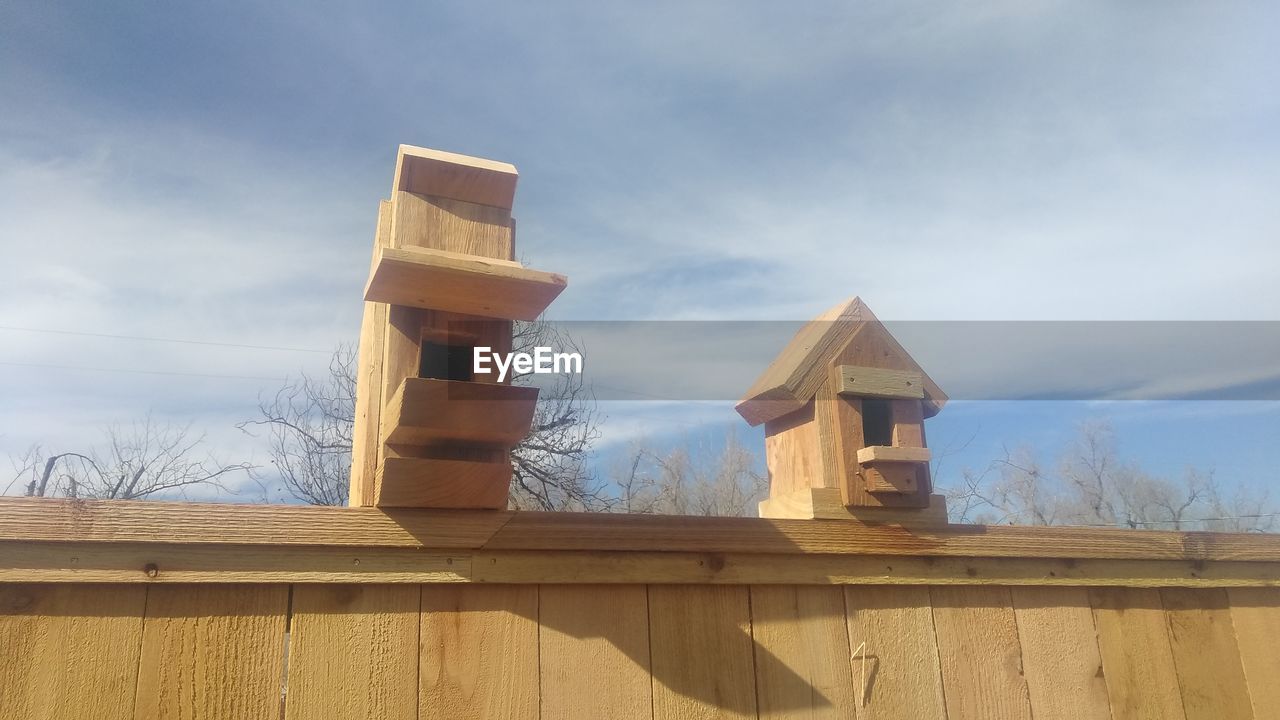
[{"left": 946, "top": 423, "right": 1277, "bottom": 532}]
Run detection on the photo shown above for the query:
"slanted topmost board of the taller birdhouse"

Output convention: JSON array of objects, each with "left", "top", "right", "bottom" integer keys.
[{"left": 392, "top": 145, "right": 520, "bottom": 210}]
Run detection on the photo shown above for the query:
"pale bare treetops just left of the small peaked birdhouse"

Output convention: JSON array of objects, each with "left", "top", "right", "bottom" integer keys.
[{"left": 613, "top": 430, "right": 769, "bottom": 516}]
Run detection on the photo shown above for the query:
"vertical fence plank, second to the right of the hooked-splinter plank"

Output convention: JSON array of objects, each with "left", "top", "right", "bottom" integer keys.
[{"left": 1011, "top": 587, "right": 1111, "bottom": 720}]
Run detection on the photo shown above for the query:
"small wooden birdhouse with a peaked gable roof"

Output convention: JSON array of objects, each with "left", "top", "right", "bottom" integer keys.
[{"left": 737, "top": 297, "right": 947, "bottom": 521}]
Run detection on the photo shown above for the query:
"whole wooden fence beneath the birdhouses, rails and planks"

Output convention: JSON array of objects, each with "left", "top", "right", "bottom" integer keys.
[{"left": 0, "top": 500, "right": 1280, "bottom": 720}]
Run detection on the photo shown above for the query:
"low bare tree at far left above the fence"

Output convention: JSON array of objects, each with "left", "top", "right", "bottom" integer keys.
[{"left": 14, "top": 415, "right": 250, "bottom": 500}]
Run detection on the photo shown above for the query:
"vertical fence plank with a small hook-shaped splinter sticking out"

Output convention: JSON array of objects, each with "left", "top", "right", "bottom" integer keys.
[{"left": 845, "top": 587, "right": 946, "bottom": 720}]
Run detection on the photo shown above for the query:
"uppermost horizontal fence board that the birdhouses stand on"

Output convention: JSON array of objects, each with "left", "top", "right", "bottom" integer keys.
[{"left": 0, "top": 497, "right": 1280, "bottom": 562}]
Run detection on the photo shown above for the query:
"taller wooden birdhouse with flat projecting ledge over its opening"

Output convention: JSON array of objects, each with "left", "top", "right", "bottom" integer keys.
[{"left": 349, "top": 145, "right": 566, "bottom": 509}]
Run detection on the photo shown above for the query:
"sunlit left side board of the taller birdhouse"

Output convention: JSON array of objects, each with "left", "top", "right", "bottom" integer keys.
[{"left": 347, "top": 200, "right": 390, "bottom": 507}]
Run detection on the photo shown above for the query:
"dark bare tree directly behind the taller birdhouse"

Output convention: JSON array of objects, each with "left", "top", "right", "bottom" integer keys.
[{"left": 247, "top": 316, "right": 609, "bottom": 510}]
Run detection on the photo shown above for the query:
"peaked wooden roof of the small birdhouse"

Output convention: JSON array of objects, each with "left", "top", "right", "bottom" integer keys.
[{"left": 736, "top": 297, "right": 947, "bottom": 425}]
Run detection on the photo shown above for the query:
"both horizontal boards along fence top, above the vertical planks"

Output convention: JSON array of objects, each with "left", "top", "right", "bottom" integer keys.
[{"left": 0, "top": 498, "right": 1280, "bottom": 587}]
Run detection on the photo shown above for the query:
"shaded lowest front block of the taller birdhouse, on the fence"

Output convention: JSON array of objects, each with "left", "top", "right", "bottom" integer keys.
[{"left": 374, "top": 457, "right": 511, "bottom": 510}]
